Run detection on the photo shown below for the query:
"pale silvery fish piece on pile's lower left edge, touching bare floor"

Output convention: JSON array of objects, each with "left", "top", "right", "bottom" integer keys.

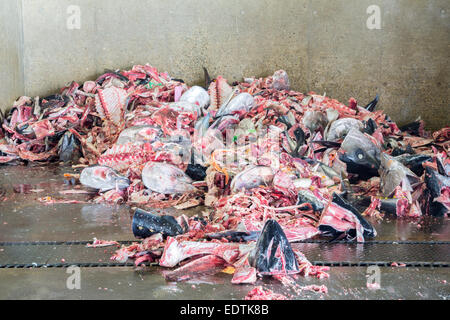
[{"left": 80, "top": 165, "right": 130, "bottom": 192}]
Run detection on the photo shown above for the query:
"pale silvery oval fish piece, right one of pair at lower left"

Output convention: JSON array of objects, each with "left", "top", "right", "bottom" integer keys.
[{"left": 142, "top": 162, "right": 195, "bottom": 194}]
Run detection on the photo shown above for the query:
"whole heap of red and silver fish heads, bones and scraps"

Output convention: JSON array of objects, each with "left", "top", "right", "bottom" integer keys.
[{"left": 0, "top": 65, "right": 450, "bottom": 290}]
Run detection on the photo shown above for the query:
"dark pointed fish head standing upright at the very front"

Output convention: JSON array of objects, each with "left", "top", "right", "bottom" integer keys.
[{"left": 249, "top": 219, "right": 300, "bottom": 275}]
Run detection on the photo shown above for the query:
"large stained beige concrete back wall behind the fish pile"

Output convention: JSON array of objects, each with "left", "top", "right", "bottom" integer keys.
[{"left": 0, "top": 0, "right": 450, "bottom": 128}]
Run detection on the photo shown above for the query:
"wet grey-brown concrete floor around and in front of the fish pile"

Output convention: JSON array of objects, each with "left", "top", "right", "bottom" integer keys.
[{"left": 0, "top": 166, "right": 450, "bottom": 299}]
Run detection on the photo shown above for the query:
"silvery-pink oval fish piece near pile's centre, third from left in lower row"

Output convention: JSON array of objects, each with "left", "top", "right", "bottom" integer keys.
[{"left": 230, "top": 166, "right": 274, "bottom": 192}]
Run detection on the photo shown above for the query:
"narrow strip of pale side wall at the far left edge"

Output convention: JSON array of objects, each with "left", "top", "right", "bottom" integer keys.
[{"left": 0, "top": 0, "right": 24, "bottom": 114}]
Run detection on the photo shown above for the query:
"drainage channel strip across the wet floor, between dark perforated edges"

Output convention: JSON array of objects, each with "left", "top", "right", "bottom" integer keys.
[{"left": 0, "top": 240, "right": 450, "bottom": 269}]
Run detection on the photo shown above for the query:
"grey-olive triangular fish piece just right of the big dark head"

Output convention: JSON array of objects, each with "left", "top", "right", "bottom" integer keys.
[{"left": 379, "top": 153, "right": 420, "bottom": 197}]
